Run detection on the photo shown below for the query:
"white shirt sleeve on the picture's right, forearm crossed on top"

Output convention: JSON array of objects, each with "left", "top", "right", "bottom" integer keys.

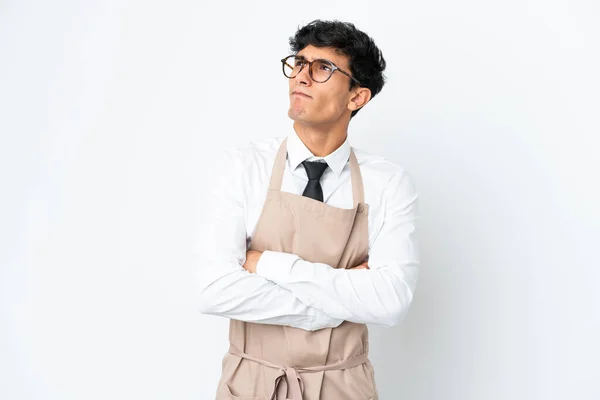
[{"left": 256, "top": 171, "right": 420, "bottom": 326}]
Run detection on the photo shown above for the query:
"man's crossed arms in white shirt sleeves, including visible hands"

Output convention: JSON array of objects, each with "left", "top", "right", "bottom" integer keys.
[{"left": 195, "top": 151, "right": 419, "bottom": 331}]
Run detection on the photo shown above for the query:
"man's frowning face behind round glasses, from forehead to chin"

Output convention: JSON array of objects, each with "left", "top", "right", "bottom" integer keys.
[{"left": 288, "top": 45, "right": 353, "bottom": 125}]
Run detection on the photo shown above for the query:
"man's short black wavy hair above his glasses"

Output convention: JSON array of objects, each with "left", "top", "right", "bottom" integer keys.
[{"left": 290, "top": 19, "right": 385, "bottom": 118}]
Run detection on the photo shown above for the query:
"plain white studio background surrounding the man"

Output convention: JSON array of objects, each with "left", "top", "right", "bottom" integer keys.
[{"left": 0, "top": 0, "right": 600, "bottom": 400}]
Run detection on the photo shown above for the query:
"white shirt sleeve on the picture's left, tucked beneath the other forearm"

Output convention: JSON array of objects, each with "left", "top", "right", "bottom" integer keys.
[{"left": 194, "top": 149, "right": 343, "bottom": 331}]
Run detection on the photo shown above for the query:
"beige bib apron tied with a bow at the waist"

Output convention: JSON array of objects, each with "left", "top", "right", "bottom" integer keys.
[{"left": 217, "top": 139, "right": 379, "bottom": 400}]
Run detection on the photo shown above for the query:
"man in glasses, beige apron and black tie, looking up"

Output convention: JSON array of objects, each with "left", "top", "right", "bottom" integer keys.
[{"left": 199, "top": 20, "right": 419, "bottom": 400}]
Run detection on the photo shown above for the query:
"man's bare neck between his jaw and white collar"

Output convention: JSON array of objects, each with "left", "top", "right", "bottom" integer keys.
[{"left": 294, "top": 121, "right": 348, "bottom": 157}]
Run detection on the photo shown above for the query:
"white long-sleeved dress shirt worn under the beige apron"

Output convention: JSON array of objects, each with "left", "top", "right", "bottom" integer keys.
[{"left": 195, "top": 131, "right": 419, "bottom": 331}]
